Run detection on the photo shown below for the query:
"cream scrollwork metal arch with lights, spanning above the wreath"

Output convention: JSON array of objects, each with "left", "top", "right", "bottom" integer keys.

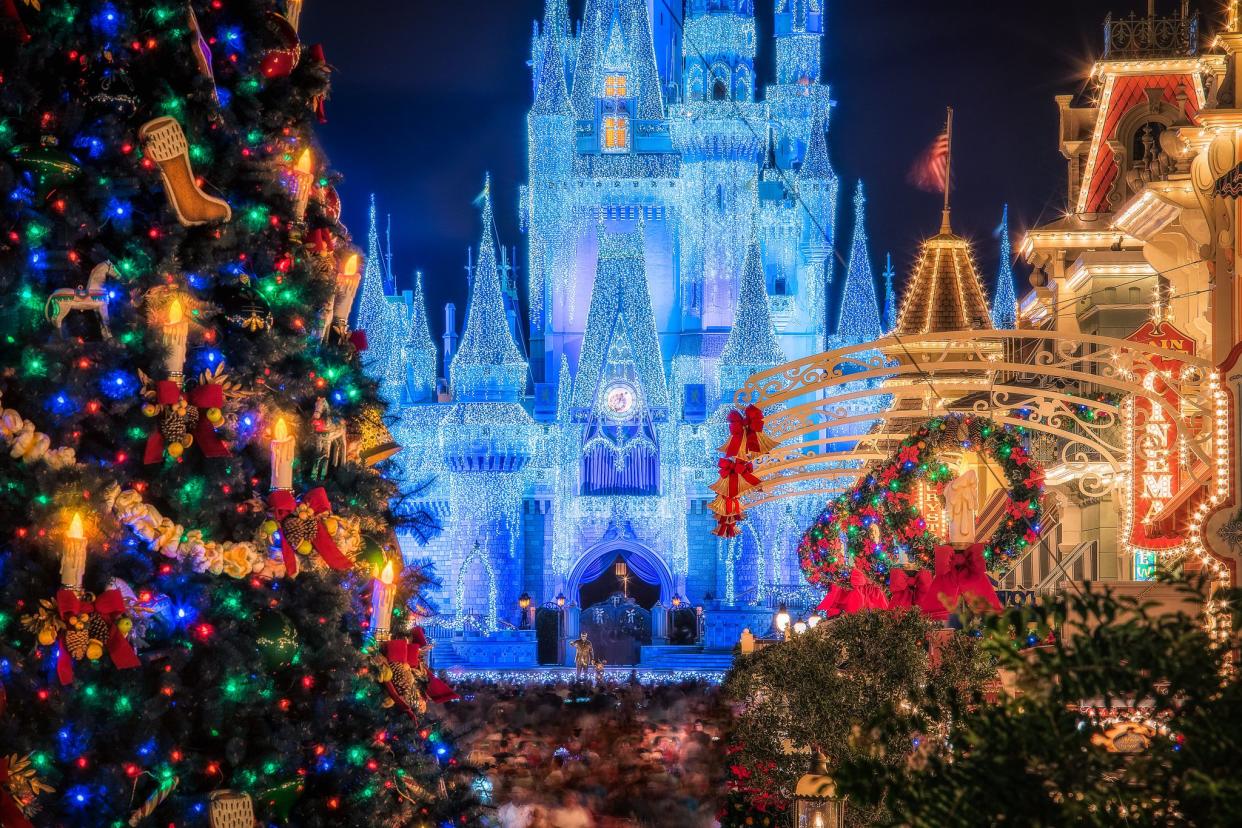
[{"left": 735, "top": 330, "right": 1230, "bottom": 583}]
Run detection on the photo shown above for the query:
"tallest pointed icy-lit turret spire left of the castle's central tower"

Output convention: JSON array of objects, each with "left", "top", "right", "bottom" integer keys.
[{"left": 451, "top": 175, "right": 528, "bottom": 401}]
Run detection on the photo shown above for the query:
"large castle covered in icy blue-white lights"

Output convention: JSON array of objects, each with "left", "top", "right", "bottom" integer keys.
[{"left": 359, "top": 0, "right": 882, "bottom": 665}]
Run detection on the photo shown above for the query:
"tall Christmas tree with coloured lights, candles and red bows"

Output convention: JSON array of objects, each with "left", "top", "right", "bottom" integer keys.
[{"left": 0, "top": 0, "right": 476, "bottom": 828}]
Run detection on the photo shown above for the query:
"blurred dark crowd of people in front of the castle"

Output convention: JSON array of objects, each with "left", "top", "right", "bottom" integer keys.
[{"left": 443, "top": 674, "right": 727, "bottom": 828}]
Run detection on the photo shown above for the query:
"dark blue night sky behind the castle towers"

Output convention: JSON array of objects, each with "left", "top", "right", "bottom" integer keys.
[{"left": 295, "top": 0, "right": 1197, "bottom": 336}]
